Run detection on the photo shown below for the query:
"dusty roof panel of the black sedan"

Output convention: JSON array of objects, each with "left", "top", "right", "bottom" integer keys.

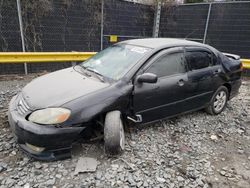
[{"left": 120, "top": 38, "right": 210, "bottom": 49}]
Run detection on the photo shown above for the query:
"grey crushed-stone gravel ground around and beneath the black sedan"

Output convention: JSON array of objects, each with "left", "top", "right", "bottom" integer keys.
[{"left": 0, "top": 75, "right": 250, "bottom": 188}]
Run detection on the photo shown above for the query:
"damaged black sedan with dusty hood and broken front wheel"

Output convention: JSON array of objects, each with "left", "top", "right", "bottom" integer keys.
[{"left": 8, "top": 38, "right": 242, "bottom": 160}]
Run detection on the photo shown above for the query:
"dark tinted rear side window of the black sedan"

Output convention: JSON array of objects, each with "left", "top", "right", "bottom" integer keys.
[{"left": 185, "top": 51, "right": 211, "bottom": 70}]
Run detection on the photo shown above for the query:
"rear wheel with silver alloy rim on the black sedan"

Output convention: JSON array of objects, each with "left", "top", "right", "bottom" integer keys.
[{"left": 205, "top": 86, "right": 229, "bottom": 115}]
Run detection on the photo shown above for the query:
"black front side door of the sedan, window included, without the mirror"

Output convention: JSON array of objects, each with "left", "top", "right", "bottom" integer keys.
[{"left": 133, "top": 47, "right": 188, "bottom": 123}]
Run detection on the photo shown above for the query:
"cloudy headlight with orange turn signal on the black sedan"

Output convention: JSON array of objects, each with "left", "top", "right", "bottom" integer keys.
[{"left": 29, "top": 108, "right": 70, "bottom": 125}]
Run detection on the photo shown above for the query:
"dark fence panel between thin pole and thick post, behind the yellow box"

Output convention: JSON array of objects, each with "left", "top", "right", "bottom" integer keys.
[{"left": 103, "top": 0, "right": 154, "bottom": 48}]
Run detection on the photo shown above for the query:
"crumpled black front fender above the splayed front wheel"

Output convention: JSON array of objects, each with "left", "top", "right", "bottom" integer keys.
[{"left": 63, "top": 81, "right": 133, "bottom": 125}]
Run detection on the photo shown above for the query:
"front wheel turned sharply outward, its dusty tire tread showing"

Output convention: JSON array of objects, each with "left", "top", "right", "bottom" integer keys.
[{"left": 104, "top": 111, "right": 125, "bottom": 155}]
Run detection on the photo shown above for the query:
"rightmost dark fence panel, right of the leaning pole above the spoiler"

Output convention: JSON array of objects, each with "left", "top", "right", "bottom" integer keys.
[{"left": 206, "top": 1, "right": 250, "bottom": 58}]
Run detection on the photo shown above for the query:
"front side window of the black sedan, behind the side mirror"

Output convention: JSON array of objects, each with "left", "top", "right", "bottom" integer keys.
[{"left": 146, "top": 52, "right": 186, "bottom": 77}]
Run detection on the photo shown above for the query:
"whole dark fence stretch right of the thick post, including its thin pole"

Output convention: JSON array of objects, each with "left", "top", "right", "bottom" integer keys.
[{"left": 160, "top": 1, "right": 250, "bottom": 58}]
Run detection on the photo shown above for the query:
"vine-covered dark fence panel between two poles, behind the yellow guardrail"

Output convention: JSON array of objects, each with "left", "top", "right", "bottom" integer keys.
[{"left": 21, "top": 0, "right": 100, "bottom": 72}]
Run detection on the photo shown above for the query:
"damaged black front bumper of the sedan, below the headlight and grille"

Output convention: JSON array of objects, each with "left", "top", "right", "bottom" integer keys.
[{"left": 8, "top": 96, "right": 85, "bottom": 161}]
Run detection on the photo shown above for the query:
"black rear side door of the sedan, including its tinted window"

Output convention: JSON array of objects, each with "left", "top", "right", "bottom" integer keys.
[{"left": 185, "top": 48, "right": 213, "bottom": 110}]
